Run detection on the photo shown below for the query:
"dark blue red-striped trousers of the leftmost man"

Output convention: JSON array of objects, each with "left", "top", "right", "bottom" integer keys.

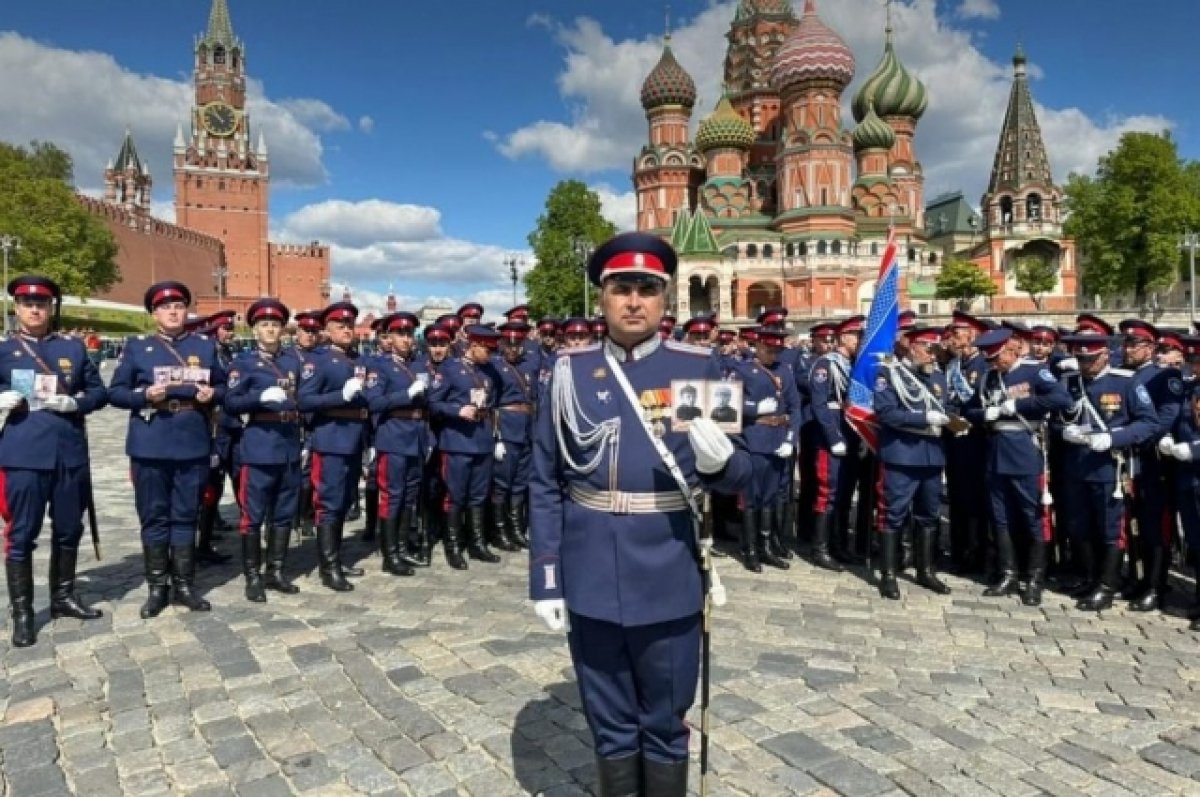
[{"left": 0, "top": 465, "right": 88, "bottom": 562}]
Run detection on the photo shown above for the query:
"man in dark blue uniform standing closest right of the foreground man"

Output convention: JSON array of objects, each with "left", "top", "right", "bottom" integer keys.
[{"left": 736, "top": 326, "right": 800, "bottom": 573}]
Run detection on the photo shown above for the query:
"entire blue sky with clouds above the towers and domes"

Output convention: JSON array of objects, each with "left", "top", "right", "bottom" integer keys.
[{"left": 0, "top": 0, "right": 1200, "bottom": 311}]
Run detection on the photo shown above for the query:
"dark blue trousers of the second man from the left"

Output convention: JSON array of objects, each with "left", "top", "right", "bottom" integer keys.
[{"left": 130, "top": 457, "right": 209, "bottom": 545}]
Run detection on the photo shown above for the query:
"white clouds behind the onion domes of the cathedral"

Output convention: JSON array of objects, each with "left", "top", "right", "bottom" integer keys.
[{"left": 496, "top": 0, "right": 1171, "bottom": 208}]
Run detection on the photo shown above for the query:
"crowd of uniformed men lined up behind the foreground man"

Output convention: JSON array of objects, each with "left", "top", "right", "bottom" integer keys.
[{"left": 0, "top": 267, "right": 1200, "bottom": 646}]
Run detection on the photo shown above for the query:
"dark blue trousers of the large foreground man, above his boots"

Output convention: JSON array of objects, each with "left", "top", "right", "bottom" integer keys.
[{"left": 566, "top": 612, "right": 701, "bottom": 762}]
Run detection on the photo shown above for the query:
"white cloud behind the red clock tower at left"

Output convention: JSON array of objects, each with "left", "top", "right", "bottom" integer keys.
[{"left": 0, "top": 32, "right": 348, "bottom": 193}]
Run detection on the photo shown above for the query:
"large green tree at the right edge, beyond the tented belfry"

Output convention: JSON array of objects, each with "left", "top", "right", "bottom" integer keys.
[{"left": 1064, "top": 133, "right": 1200, "bottom": 305}]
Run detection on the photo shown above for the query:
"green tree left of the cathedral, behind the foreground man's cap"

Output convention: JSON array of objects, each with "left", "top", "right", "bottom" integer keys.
[{"left": 524, "top": 180, "right": 617, "bottom": 317}]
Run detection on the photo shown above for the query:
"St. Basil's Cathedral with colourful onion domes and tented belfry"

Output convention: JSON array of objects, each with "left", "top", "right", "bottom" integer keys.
[{"left": 632, "top": 0, "right": 1075, "bottom": 320}]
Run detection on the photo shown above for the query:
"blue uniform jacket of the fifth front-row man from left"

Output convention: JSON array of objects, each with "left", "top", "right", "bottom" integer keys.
[{"left": 364, "top": 354, "right": 428, "bottom": 456}]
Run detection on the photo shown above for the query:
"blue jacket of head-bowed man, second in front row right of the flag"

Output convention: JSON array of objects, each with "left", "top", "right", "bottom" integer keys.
[{"left": 962, "top": 360, "right": 1070, "bottom": 475}]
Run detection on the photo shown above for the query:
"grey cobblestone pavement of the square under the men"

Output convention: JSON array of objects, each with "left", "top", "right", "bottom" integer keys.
[{"left": 0, "top": 411, "right": 1200, "bottom": 797}]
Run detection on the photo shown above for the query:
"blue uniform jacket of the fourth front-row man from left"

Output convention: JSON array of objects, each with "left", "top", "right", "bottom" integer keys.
[{"left": 296, "top": 346, "right": 367, "bottom": 456}]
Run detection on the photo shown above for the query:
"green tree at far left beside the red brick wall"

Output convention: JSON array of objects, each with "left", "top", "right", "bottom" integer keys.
[{"left": 0, "top": 142, "right": 119, "bottom": 296}]
